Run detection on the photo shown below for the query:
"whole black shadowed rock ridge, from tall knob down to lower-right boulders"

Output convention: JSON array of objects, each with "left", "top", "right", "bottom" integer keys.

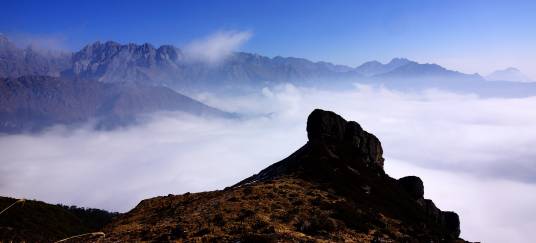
[{"left": 235, "top": 109, "right": 460, "bottom": 239}]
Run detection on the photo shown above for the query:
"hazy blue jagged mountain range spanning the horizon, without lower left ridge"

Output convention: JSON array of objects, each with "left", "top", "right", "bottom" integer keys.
[{"left": 4, "top": 36, "right": 536, "bottom": 97}]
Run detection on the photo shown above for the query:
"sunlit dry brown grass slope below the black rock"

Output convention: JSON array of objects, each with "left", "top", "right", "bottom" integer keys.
[{"left": 104, "top": 178, "right": 398, "bottom": 242}]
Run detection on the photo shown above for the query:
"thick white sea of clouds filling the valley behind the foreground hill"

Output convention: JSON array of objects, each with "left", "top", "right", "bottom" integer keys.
[{"left": 0, "top": 84, "right": 536, "bottom": 242}]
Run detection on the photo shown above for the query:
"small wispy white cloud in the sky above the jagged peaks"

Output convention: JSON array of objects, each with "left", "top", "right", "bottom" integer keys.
[{"left": 184, "top": 31, "right": 252, "bottom": 64}]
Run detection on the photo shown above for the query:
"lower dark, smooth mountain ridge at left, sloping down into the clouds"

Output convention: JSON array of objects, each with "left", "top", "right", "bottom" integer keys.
[{"left": 0, "top": 76, "right": 230, "bottom": 133}]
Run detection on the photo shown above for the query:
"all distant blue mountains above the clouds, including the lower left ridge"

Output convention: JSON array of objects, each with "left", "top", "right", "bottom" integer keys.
[{"left": 0, "top": 35, "right": 536, "bottom": 133}]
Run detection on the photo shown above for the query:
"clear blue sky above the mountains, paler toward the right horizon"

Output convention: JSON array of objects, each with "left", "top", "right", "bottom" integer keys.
[{"left": 0, "top": 0, "right": 536, "bottom": 77}]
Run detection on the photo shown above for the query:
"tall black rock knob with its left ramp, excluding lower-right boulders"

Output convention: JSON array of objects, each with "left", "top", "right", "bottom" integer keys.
[{"left": 237, "top": 109, "right": 385, "bottom": 186}]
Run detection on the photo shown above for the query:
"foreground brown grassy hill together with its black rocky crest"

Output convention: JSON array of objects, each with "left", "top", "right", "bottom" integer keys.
[{"left": 102, "top": 110, "right": 465, "bottom": 242}]
